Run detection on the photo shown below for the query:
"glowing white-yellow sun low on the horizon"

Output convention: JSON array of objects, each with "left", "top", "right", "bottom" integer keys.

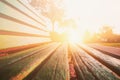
[{"left": 56, "top": 27, "right": 83, "bottom": 43}]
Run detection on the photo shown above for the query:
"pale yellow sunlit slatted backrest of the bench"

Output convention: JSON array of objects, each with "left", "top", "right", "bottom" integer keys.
[{"left": 0, "top": 0, "right": 51, "bottom": 49}]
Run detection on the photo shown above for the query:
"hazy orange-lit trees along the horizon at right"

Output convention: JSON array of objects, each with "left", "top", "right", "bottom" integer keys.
[{"left": 83, "top": 26, "right": 120, "bottom": 43}]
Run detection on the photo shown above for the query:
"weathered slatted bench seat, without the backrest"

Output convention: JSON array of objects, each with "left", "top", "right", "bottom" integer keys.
[{"left": 0, "top": 43, "right": 120, "bottom": 80}]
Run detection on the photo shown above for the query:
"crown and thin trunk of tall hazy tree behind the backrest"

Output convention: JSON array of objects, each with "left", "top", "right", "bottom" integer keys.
[{"left": 30, "top": 0, "right": 64, "bottom": 31}]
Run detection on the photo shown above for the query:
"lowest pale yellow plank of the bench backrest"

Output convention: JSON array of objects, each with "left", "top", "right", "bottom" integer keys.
[{"left": 0, "top": 35, "right": 51, "bottom": 49}]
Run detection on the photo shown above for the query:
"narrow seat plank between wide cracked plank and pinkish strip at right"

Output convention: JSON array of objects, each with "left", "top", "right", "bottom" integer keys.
[{"left": 80, "top": 44, "right": 120, "bottom": 76}]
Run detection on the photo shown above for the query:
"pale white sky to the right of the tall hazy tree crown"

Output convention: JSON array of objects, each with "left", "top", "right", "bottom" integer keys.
[{"left": 65, "top": 0, "right": 120, "bottom": 33}]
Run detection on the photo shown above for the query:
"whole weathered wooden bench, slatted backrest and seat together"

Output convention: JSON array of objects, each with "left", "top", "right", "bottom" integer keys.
[{"left": 0, "top": 0, "right": 120, "bottom": 80}]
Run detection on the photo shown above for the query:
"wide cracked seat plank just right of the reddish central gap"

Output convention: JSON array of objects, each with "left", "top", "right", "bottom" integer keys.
[{"left": 71, "top": 45, "right": 120, "bottom": 80}]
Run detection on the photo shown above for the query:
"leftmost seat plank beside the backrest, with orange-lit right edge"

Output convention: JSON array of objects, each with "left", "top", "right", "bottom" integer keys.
[{"left": 0, "top": 44, "right": 60, "bottom": 80}]
